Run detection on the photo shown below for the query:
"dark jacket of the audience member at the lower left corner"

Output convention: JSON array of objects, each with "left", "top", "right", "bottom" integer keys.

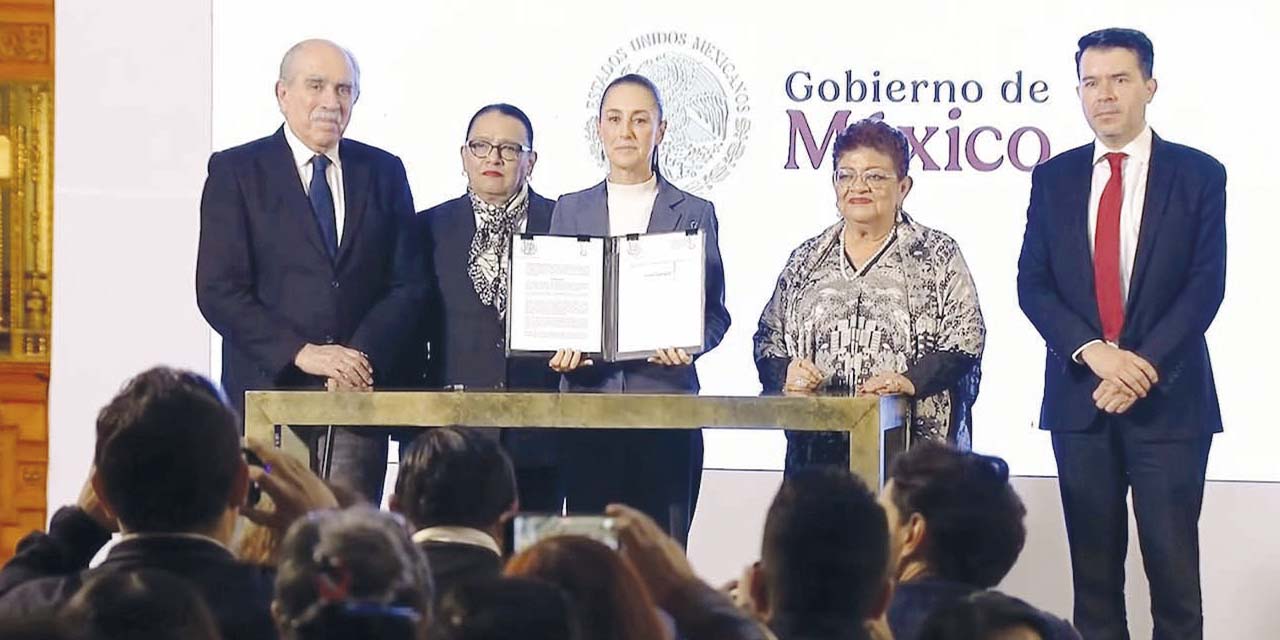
[{"left": 0, "top": 507, "right": 276, "bottom": 640}]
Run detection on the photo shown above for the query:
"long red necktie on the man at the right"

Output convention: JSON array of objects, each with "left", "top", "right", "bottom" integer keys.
[{"left": 1093, "top": 154, "right": 1126, "bottom": 343}]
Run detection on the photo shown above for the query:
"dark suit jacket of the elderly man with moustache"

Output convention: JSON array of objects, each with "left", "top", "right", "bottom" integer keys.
[{"left": 196, "top": 127, "right": 425, "bottom": 412}]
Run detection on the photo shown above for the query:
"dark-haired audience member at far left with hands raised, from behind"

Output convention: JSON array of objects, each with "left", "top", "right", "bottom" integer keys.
[{"left": 0, "top": 367, "right": 337, "bottom": 640}]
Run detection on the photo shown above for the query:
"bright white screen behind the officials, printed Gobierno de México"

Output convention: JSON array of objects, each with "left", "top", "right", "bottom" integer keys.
[{"left": 209, "top": 0, "right": 1280, "bottom": 480}]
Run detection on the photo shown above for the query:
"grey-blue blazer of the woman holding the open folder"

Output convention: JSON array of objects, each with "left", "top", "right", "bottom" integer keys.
[{"left": 552, "top": 175, "right": 730, "bottom": 393}]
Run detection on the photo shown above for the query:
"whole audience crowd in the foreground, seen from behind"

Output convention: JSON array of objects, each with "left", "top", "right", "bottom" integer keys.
[{"left": 0, "top": 367, "right": 1079, "bottom": 640}]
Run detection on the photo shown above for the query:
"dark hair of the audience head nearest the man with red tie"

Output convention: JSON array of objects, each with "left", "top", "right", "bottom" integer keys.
[{"left": 888, "top": 442, "right": 1027, "bottom": 589}]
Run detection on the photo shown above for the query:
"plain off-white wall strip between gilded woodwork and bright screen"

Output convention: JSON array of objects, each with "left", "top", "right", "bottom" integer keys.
[{"left": 49, "top": 0, "right": 211, "bottom": 516}]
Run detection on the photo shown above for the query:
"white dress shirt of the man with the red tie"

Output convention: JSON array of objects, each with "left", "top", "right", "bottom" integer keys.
[{"left": 1071, "top": 125, "right": 1152, "bottom": 362}]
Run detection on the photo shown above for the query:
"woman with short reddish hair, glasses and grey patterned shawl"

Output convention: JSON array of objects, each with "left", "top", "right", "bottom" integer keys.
[{"left": 755, "top": 119, "right": 986, "bottom": 471}]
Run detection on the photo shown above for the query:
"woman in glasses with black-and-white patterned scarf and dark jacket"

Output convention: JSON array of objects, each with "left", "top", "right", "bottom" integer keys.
[{"left": 417, "top": 104, "right": 563, "bottom": 511}]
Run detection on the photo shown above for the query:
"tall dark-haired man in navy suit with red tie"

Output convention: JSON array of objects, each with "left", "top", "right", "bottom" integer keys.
[{"left": 1018, "top": 28, "right": 1226, "bottom": 640}]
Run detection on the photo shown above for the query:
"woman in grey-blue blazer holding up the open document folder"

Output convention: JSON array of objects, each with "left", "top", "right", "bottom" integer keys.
[{"left": 549, "top": 74, "right": 730, "bottom": 541}]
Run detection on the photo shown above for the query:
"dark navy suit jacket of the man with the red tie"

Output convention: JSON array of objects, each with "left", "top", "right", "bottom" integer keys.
[{"left": 1018, "top": 136, "right": 1226, "bottom": 439}]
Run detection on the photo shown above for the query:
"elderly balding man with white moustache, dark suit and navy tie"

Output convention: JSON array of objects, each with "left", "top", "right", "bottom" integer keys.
[{"left": 196, "top": 40, "right": 425, "bottom": 500}]
